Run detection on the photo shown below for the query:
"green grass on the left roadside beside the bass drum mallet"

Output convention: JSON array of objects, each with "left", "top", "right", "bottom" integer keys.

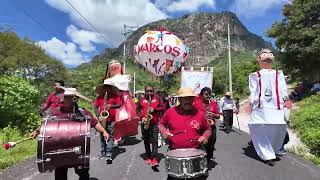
[{"left": 0, "top": 127, "right": 37, "bottom": 170}]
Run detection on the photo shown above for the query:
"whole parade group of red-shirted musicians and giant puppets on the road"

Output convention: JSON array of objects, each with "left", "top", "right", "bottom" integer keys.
[{"left": 31, "top": 49, "right": 291, "bottom": 180}]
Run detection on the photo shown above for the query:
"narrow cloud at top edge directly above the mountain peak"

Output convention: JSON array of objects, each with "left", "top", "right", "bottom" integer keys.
[{"left": 162, "top": 0, "right": 215, "bottom": 12}]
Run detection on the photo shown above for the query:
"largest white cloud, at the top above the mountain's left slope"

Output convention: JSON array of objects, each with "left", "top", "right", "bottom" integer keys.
[{"left": 46, "top": 0, "right": 167, "bottom": 46}]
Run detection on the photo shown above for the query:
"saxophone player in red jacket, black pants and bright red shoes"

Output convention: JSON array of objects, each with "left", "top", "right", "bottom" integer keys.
[{"left": 137, "top": 85, "right": 164, "bottom": 168}]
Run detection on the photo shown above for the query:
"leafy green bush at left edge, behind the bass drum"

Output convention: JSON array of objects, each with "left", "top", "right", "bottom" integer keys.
[{"left": 0, "top": 76, "right": 40, "bottom": 133}]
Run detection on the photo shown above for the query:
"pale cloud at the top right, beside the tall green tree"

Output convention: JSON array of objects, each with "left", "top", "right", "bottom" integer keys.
[{"left": 231, "top": 0, "right": 289, "bottom": 18}]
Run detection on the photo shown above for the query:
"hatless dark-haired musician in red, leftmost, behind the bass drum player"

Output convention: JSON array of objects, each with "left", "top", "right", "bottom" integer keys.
[{"left": 41, "top": 80, "right": 64, "bottom": 113}]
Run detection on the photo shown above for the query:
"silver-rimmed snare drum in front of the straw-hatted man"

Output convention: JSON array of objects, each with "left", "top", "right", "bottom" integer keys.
[{"left": 165, "top": 148, "right": 208, "bottom": 178}]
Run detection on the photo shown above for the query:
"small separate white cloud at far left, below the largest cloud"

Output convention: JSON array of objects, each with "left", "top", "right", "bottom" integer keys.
[{"left": 37, "top": 37, "right": 88, "bottom": 66}]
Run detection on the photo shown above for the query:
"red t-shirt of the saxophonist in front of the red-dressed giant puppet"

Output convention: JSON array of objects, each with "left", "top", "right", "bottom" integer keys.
[{"left": 94, "top": 95, "right": 121, "bottom": 121}]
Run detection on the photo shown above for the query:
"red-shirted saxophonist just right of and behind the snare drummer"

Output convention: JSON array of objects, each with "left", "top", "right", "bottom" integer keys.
[{"left": 193, "top": 87, "right": 220, "bottom": 162}]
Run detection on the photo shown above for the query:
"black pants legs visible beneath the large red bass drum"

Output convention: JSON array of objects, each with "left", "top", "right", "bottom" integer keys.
[{"left": 54, "top": 167, "right": 90, "bottom": 180}]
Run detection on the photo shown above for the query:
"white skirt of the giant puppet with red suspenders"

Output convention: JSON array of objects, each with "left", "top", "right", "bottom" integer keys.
[{"left": 248, "top": 124, "right": 286, "bottom": 160}]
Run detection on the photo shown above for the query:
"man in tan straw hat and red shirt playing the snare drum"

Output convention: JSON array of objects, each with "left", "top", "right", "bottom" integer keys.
[{"left": 159, "top": 88, "right": 211, "bottom": 149}]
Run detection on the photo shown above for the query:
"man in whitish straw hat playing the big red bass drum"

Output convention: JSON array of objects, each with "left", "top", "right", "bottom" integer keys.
[{"left": 30, "top": 87, "right": 109, "bottom": 180}]
